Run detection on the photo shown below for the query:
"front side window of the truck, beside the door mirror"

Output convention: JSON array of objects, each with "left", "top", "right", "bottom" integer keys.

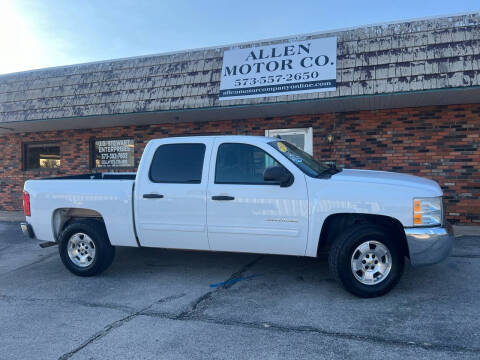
[{"left": 215, "top": 143, "right": 282, "bottom": 185}]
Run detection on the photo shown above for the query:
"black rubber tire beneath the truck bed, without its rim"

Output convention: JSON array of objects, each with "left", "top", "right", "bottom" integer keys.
[{"left": 58, "top": 220, "right": 115, "bottom": 276}]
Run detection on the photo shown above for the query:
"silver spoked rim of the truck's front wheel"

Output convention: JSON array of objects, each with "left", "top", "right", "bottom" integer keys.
[{"left": 351, "top": 240, "right": 392, "bottom": 285}]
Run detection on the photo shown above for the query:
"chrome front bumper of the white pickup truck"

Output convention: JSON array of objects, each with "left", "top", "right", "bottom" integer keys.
[{"left": 405, "top": 225, "right": 454, "bottom": 266}]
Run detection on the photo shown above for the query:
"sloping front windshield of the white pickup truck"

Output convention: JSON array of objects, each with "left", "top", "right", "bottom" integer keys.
[{"left": 268, "top": 141, "right": 340, "bottom": 177}]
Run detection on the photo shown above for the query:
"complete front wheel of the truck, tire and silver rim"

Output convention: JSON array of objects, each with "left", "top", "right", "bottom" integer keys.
[{"left": 328, "top": 224, "right": 405, "bottom": 298}]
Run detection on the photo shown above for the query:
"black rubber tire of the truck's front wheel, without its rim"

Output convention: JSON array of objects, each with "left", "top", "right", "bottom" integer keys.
[{"left": 328, "top": 224, "right": 405, "bottom": 298}]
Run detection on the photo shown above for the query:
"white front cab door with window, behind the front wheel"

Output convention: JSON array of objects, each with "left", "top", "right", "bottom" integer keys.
[{"left": 207, "top": 138, "right": 308, "bottom": 255}]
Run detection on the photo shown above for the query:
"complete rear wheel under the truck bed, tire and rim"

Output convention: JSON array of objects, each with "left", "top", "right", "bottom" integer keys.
[{"left": 58, "top": 220, "right": 115, "bottom": 276}]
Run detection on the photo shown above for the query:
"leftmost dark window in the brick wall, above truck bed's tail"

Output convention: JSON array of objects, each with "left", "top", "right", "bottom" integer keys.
[{"left": 23, "top": 143, "right": 60, "bottom": 170}]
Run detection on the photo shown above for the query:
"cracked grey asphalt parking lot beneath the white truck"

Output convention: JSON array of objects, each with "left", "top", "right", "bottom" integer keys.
[{"left": 0, "top": 222, "right": 480, "bottom": 359}]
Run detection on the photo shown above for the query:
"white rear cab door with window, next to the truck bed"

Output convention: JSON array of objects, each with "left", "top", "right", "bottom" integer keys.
[{"left": 134, "top": 138, "right": 213, "bottom": 250}]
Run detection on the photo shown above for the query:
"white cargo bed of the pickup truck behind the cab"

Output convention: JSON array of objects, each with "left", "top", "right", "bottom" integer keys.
[{"left": 25, "top": 178, "right": 137, "bottom": 246}]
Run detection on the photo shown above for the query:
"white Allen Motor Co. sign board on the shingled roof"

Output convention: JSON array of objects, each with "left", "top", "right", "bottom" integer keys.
[{"left": 220, "top": 37, "right": 337, "bottom": 100}]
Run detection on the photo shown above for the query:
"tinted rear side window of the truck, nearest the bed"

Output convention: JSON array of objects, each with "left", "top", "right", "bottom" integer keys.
[{"left": 150, "top": 143, "right": 205, "bottom": 184}]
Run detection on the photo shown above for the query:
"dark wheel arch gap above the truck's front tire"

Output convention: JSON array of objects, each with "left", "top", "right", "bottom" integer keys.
[{"left": 317, "top": 213, "right": 409, "bottom": 257}]
